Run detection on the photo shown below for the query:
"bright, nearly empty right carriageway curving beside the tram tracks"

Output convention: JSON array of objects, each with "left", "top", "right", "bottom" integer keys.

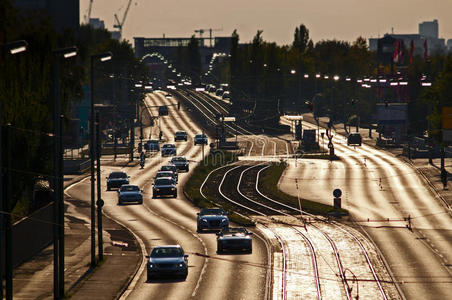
[{"left": 280, "top": 116, "right": 452, "bottom": 299}]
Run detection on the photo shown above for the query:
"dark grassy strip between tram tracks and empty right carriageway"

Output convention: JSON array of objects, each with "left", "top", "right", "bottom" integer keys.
[{"left": 259, "top": 161, "right": 348, "bottom": 216}]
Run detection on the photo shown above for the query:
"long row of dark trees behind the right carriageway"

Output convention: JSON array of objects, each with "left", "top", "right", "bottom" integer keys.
[{"left": 204, "top": 25, "right": 452, "bottom": 141}]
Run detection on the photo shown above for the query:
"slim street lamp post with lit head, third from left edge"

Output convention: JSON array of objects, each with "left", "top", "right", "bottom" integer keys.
[{"left": 89, "top": 52, "right": 112, "bottom": 268}]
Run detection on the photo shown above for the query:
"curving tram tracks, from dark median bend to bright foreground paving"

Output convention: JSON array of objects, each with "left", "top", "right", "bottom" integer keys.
[{"left": 200, "top": 163, "right": 392, "bottom": 299}]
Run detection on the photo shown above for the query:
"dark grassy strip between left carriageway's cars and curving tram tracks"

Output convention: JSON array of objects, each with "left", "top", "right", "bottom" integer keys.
[{"left": 184, "top": 151, "right": 255, "bottom": 226}]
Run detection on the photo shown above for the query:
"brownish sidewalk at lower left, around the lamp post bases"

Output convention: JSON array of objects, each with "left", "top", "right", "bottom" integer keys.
[{"left": 13, "top": 157, "right": 143, "bottom": 300}]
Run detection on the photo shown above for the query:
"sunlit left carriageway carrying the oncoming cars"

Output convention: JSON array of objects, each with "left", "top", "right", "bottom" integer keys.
[{"left": 64, "top": 92, "right": 268, "bottom": 299}]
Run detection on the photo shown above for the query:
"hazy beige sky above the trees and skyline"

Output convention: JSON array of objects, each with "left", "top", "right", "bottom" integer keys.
[{"left": 80, "top": 0, "right": 452, "bottom": 45}]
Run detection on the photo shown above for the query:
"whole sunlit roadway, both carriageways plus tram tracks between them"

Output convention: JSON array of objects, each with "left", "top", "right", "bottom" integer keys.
[{"left": 61, "top": 92, "right": 452, "bottom": 299}]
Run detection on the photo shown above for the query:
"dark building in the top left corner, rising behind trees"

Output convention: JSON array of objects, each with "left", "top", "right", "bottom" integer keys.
[{"left": 13, "top": 0, "right": 80, "bottom": 30}]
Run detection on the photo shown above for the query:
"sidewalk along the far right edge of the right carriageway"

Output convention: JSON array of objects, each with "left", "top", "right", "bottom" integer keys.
[{"left": 303, "top": 113, "right": 452, "bottom": 213}]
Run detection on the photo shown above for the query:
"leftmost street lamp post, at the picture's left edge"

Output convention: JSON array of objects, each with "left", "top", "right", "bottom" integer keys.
[{"left": 0, "top": 40, "right": 28, "bottom": 300}]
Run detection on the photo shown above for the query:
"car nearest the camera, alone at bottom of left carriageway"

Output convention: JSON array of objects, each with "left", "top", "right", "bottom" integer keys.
[{"left": 147, "top": 245, "right": 188, "bottom": 281}]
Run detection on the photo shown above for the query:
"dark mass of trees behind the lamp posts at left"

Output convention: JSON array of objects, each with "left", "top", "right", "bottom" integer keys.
[{"left": 0, "top": 0, "right": 147, "bottom": 220}]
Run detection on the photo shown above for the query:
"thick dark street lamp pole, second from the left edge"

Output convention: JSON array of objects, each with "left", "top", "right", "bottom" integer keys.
[{"left": 52, "top": 46, "right": 77, "bottom": 299}]
